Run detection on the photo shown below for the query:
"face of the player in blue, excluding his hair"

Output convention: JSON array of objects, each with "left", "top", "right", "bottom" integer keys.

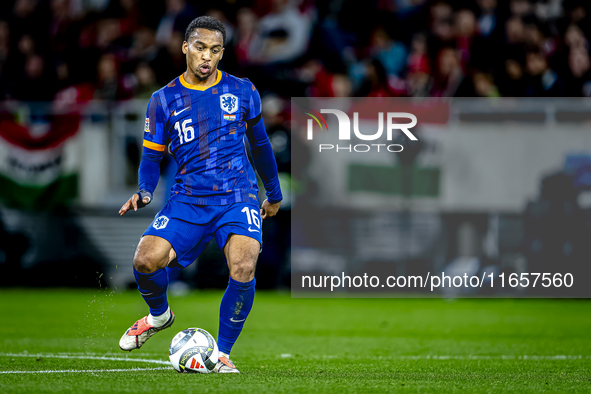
[{"left": 183, "top": 29, "right": 224, "bottom": 81}]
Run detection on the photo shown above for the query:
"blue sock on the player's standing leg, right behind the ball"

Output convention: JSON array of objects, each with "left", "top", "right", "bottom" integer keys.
[{"left": 218, "top": 278, "right": 256, "bottom": 354}]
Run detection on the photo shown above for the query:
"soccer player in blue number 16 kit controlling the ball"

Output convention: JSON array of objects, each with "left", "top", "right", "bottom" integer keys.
[{"left": 119, "top": 16, "right": 283, "bottom": 373}]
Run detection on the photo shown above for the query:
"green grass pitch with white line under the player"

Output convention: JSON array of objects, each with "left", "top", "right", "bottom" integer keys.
[{"left": 0, "top": 289, "right": 591, "bottom": 394}]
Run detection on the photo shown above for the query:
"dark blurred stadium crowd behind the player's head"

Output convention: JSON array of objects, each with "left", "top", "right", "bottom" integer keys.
[{"left": 0, "top": 0, "right": 591, "bottom": 101}]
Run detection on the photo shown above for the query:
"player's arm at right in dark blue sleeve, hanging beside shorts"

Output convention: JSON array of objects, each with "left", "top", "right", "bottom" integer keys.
[{"left": 246, "top": 84, "right": 283, "bottom": 219}]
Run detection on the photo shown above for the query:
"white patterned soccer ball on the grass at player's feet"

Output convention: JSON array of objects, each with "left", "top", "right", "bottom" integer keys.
[{"left": 168, "top": 328, "right": 219, "bottom": 373}]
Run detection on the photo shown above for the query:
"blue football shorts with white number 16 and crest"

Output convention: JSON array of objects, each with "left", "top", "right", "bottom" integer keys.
[{"left": 143, "top": 201, "right": 263, "bottom": 267}]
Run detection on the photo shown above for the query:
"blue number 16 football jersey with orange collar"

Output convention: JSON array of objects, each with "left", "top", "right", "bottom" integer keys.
[{"left": 144, "top": 70, "right": 261, "bottom": 205}]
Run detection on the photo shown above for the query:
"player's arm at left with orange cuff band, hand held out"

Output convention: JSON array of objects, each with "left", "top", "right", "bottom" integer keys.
[{"left": 119, "top": 93, "right": 166, "bottom": 216}]
